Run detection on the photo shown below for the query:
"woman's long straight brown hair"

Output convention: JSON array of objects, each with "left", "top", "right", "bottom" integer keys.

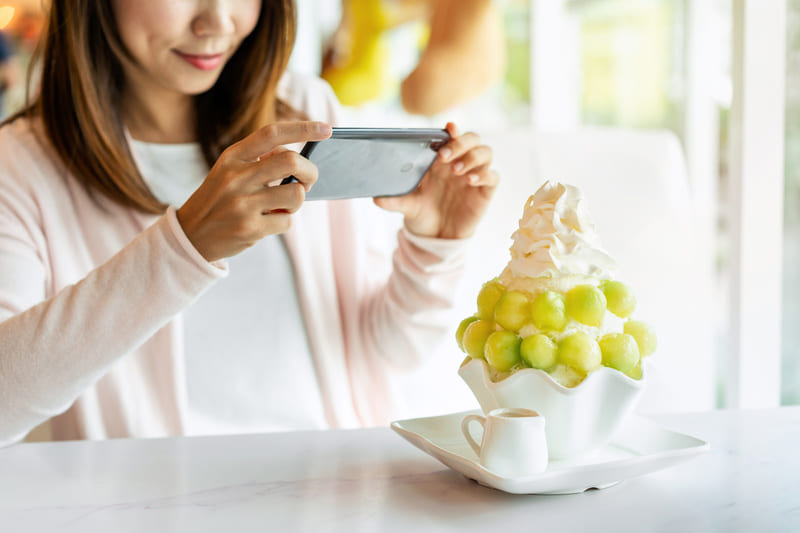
[{"left": 13, "top": 0, "right": 296, "bottom": 213}]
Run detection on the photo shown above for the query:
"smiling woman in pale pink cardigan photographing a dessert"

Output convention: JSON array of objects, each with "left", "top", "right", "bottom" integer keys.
[{"left": 0, "top": 0, "right": 497, "bottom": 443}]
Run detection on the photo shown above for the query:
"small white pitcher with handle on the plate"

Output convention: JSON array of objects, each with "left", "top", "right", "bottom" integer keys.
[{"left": 461, "top": 408, "right": 548, "bottom": 478}]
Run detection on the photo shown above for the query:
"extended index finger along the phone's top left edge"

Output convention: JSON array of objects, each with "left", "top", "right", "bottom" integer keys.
[{"left": 225, "top": 122, "right": 331, "bottom": 163}]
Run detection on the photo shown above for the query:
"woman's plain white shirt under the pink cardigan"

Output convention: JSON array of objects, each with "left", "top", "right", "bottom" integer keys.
[{"left": 131, "top": 140, "right": 327, "bottom": 435}]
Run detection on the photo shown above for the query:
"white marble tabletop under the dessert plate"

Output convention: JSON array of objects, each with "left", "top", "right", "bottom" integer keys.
[{"left": 0, "top": 407, "right": 800, "bottom": 533}]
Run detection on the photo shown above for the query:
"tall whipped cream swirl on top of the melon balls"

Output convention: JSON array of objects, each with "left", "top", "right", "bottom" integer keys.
[{"left": 508, "top": 181, "right": 616, "bottom": 279}]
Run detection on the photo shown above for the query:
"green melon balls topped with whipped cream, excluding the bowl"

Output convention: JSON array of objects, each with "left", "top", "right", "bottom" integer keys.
[{"left": 456, "top": 182, "right": 656, "bottom": 387}]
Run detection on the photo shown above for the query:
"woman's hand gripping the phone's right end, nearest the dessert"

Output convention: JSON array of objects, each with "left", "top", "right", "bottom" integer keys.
[{"left": 374, "top": 123, "right": 499, "bottom": 239}]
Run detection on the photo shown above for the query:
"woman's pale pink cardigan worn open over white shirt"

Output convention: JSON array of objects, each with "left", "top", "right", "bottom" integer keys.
[{"left": 0, "top": 72, "right": 464, "bottom": 445}]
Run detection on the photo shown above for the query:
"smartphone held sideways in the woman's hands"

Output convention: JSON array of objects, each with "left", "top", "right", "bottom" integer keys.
[{"left": 283, "top": 128, "right": 450, "bottom": 200}]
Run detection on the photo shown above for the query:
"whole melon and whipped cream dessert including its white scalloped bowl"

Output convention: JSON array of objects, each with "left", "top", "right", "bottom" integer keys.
[{"left": 456, "top": 182, "right": 656, "bottom": 459}]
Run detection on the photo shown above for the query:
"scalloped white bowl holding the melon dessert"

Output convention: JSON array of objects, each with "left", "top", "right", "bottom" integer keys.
[{"left": 458, "top": 359, "right": 646, "bottom": 459}]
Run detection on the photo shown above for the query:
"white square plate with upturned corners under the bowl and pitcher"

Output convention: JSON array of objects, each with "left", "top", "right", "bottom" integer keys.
[{"left": 391, "top": 410, "right": 709, "bottom": 494}]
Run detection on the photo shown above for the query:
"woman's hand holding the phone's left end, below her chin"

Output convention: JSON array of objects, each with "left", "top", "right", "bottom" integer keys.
[{"left": 177, "top": 122, "right": 331, "bottom": 261}]
